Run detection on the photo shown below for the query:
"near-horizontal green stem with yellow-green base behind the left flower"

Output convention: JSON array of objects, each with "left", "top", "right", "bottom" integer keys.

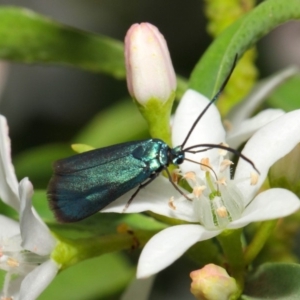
[{"left": 51, "top": 230, "right": 158, "bottom": 270}]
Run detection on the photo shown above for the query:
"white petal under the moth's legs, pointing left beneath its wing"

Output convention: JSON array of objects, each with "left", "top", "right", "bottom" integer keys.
[{"left": 101, "top": 176, "right": 198, "bottom": 222}]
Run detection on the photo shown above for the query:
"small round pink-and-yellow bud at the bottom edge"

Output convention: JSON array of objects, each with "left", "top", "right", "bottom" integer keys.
[{"left": 190, "top": 264, "right": 238, "bottom": 300}]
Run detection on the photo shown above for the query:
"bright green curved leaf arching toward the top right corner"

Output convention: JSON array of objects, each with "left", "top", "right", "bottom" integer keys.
[{"left": 189, "top": 0, "right": 300, "bottom": 99}]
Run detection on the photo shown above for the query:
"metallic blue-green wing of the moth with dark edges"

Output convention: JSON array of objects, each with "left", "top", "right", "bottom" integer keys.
[{"left": 48, "top": 142, "right": 153, "bottom": 222}]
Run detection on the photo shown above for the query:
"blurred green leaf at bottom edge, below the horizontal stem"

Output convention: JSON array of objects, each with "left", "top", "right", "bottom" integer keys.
[{"left": 38, "top": 254, "right": 135, "bottom": 300}]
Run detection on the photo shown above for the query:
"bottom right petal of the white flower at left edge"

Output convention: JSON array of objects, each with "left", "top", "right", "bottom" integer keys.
[{"left": 19, "top": 259, "right": 59, "bottom": 300}]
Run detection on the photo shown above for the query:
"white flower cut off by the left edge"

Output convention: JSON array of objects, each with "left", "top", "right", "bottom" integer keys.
[{"left": 0, "top": 116, "right": 59, "bottom": 300}]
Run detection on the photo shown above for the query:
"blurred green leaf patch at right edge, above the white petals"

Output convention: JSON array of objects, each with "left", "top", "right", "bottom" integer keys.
[{"left": 267, "top": 75, "right": 300, "bottom": 112}]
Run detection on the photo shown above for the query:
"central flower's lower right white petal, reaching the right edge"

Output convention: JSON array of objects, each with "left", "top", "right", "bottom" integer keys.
[{"left": 228, "top": 188, "right": 300, "bottom": 229}]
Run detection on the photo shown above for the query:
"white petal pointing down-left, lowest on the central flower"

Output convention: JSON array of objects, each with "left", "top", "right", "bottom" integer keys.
[{"left": 137, "top": 225, "right": 221, "bottom": 278}]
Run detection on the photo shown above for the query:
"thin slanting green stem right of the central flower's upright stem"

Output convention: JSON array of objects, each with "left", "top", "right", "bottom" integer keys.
[{"left": 244, "top": 220, "right": 277, "bottom": 265}]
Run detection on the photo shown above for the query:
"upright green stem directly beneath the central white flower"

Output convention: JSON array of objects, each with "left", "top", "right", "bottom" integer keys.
[{"left": 217, "top": 229, "right": 245, "bottom": 299}]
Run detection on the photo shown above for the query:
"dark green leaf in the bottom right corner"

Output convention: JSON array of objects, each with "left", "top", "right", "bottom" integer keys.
[{"left": 243, "top": 263, "right": 300, "bottom": 300}]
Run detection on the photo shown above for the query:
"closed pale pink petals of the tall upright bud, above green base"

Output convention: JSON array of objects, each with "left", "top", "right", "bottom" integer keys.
[{"left": 125, "top": 23, "right": 176, "bottom": 105}]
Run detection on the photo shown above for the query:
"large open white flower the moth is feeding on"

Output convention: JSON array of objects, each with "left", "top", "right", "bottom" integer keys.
[{"left": 103, "top": 90, "right": 300, "bottom": 278}]
